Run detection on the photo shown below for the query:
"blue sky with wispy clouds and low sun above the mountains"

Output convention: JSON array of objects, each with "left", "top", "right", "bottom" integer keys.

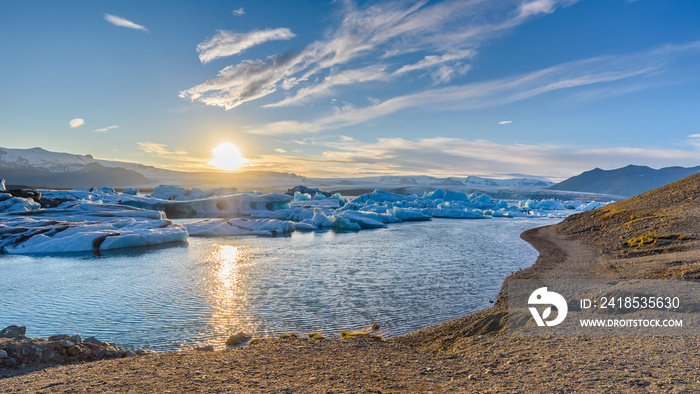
[{"left": 0, "top": 0, "right": 700, "bottom": 180}]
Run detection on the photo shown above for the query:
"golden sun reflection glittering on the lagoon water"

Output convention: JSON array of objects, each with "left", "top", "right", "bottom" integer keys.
[{"left": 207, "top": 245, "right": 260, "bottom": 348}]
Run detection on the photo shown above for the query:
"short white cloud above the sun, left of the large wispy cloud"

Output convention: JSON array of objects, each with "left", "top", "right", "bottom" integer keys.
[{"left": 197, "top": 27, "right": 296, "bottom": 63}]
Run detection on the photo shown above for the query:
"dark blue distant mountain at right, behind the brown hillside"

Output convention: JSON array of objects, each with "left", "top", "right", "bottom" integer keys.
[{"left": 549, "top": 165, "right": 700, "bottom": 197}]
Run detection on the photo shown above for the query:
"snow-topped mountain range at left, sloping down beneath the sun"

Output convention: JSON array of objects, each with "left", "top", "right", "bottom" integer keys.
[{"left": 0, "top": 148, "right": 306, "bottom": 189}]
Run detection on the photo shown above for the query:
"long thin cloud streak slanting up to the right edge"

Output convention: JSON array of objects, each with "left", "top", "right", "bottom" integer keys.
[{"left": 249, "top": 41, "right": 700, "bottom": 134}]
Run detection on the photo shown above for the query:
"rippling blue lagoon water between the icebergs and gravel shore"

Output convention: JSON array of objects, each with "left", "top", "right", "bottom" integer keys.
[{"left": 0, "top": 219, "right": 558, "bottom": 350}]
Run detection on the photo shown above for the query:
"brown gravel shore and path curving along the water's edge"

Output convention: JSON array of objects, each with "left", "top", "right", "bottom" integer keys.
[{"left": 0, "top": 217, "right": 700, "bottom": 393}]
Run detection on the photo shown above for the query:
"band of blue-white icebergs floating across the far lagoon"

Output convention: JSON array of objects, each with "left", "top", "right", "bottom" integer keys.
[{"left": 0, "top": 185, "right": 606, "bottom": 254}]
